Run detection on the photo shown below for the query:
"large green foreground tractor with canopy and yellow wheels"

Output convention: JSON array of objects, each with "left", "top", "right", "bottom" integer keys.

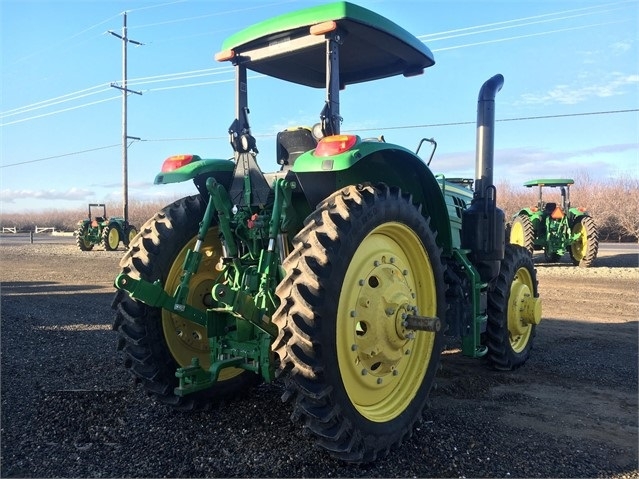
[{"left": 113, "top": 2, "right": 541, "bottom": 463}]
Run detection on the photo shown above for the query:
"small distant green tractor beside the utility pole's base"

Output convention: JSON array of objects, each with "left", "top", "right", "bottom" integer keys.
[{"left": 74, "top": 203, "right": 138, "bottom": 251}]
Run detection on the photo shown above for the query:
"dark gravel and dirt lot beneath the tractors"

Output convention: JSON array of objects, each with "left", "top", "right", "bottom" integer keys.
[{"left": 0, "top": 240, "right": 639, "bottom": 477}]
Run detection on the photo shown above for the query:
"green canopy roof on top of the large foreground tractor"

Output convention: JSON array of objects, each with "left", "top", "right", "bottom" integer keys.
[{"left": 216, "top": 2, "right": 435, "bottom": 88}]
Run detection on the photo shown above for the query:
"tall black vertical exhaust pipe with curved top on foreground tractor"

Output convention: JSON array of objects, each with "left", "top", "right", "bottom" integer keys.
[{"left": 461, "top": 74, "right": 506, "bottom": 282}]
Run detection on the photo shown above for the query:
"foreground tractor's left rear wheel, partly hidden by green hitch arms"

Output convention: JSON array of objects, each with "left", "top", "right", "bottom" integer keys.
[{"left": 113, "top": 195, "right": 260, "bottom": 410}]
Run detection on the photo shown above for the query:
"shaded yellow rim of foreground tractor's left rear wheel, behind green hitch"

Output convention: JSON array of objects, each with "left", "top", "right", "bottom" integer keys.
[{"left": 162, "top": 228, "right": 243, "bottom": 381}]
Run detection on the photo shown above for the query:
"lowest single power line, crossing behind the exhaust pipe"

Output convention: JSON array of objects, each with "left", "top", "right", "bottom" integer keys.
[{"left": 0, "top": 108, "right": 639, "bottom": 168}]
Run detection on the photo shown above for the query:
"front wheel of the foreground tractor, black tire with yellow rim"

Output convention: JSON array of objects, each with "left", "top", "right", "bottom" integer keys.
[{"left": 484, "top": 244, "right": 541, "bottom": 370}]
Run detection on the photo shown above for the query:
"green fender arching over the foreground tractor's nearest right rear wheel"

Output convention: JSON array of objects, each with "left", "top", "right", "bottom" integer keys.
[{"left": 292, "top": 137, "right": 452, "bottom": 253}]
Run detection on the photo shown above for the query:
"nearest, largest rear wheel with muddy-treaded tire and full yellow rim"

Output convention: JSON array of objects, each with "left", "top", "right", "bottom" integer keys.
[{"left": 273, "top": 185, "right": 446, "bottom": 462}]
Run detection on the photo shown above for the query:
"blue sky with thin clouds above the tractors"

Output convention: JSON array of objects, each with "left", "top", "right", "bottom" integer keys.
[{"left": 0, "top": 0, "right": 639, "bottom": 214}]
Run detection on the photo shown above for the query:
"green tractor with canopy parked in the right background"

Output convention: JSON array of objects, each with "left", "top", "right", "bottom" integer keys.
[{"left": 509, "top": 179, "right": 599, "bottom": 267}]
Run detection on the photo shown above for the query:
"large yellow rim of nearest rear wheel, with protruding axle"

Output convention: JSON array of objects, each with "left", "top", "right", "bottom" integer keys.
[{"left": 336, "top": 223, "right": 437, "bottom": 422}]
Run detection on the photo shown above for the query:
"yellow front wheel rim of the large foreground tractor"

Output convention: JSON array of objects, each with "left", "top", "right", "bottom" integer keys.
[{"left": 508, "top": 268, "right": 541, "bottom": 353}]
